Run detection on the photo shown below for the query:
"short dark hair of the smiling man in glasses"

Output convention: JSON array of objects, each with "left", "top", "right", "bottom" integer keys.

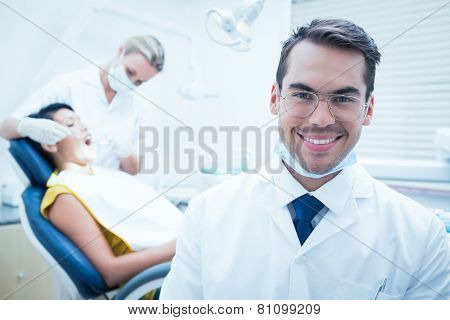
[{"left": 277, "top": 19, "right": 381, "bottom": 101}]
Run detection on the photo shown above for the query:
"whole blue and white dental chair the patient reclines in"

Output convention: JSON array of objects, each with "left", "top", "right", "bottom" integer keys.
[{"left": 9, "top": 139, "right": 170, "bottom": 300}]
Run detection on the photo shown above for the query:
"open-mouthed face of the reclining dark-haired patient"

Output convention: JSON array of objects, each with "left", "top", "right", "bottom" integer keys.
[{"left": 53, "top": 109, "right": 95, "bottom": 165}]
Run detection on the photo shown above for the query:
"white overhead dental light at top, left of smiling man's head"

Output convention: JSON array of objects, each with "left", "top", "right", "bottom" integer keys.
[{"left": 205, "top": 0, "right": 265, "bottom": 51}]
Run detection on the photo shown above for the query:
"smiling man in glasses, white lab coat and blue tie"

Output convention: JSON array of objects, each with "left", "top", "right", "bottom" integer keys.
[{"left": 161, "top": 20, "right": 450, "bottom": 299}]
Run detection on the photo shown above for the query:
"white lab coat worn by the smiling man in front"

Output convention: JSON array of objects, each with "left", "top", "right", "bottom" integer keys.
[{"left": 161, "top": 159, "right": 450, "bottom": 299}]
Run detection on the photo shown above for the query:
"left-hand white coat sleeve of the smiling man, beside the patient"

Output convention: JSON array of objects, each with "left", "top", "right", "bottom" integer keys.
[{"left": 160, "top": 199, "right": 204, "bottom": 300}]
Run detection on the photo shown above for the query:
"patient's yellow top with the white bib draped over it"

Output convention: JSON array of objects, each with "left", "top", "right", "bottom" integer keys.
[{"left": 41, "top": 167, "right": 182, "bottom": 255}]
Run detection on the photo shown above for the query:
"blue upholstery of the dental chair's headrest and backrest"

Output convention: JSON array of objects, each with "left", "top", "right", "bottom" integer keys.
[{"left": 9, "top": 139, "right": 111, "bottom": 299}]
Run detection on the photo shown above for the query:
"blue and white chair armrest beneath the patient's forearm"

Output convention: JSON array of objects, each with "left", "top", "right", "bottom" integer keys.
[{"left": 114, "top": 262, "right": 170, "bottom": 300}]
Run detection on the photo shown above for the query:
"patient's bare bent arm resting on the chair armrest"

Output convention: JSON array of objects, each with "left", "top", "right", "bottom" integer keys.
[{"left": 49, "top": 194, "right": 175, "bottom": 287}]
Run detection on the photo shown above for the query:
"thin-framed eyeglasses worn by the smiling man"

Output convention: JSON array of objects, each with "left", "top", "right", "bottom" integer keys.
[{"left": 280, "top": 91, "right": 368, "bottom": 122}]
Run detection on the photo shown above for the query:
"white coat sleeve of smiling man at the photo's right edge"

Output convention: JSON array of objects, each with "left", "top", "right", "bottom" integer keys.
[{"left": 404, "top": 217, "right": 450, "bottom": 300}]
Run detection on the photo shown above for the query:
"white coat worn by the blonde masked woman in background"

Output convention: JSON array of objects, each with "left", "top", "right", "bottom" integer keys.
[{"left": 11, "top": 66, "right": 149, "bottom": 169}]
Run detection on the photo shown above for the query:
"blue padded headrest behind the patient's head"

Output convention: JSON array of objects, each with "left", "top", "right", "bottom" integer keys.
[{"left": 9, "top": 138, "right": 52, "bottom": 187}]
